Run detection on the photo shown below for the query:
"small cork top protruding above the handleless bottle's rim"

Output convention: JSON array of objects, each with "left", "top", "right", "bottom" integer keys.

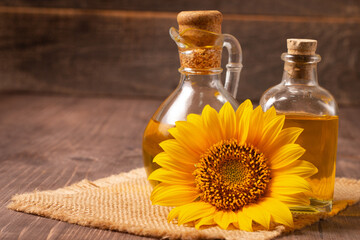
[{"left": 287, "top": 38, "right": 317, "bottom": 55}]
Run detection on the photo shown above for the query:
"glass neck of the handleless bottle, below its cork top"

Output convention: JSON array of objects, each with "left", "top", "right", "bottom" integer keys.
[{"left": 281, "top": 53, "right": 321, "bottom": 86}]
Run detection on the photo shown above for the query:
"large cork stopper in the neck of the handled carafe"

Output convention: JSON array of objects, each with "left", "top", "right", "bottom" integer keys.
[{"left": 177, "top": 10, "right": 223, "bottom": 70}]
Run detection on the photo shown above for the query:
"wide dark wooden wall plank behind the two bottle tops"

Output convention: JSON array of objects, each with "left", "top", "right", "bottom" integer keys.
[{"left": 0, "top": 8, "right": 360, "bottom": 106}]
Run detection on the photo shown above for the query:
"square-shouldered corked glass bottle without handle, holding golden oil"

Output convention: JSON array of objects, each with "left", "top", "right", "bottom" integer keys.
[{"left": 260, "top": 39, "right": 338, "bottom": 212}]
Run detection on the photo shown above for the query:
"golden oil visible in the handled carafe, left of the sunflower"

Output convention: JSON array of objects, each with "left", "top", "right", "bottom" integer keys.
[{"left": 143, "top": 118, "right": 174, "bottom": 186}]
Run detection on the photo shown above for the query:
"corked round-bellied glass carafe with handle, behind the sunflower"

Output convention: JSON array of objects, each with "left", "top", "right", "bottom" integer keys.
[{"left": 143, "top": 11, "right": 242, "bottom": 186}]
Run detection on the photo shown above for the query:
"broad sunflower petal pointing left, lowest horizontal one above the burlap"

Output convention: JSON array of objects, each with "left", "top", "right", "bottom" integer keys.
[{"left": 150, "top": 183, "right": 200, "bottom": 207}]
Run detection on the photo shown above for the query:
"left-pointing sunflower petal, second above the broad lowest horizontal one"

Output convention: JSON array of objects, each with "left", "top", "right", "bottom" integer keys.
[{"left": 153, "top": 152, "right": 195, "bottom": 173}]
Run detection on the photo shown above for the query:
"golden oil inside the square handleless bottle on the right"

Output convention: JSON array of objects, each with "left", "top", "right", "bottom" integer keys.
[{"left": 284, "top": 115, "right": 339, "bottom": 208}]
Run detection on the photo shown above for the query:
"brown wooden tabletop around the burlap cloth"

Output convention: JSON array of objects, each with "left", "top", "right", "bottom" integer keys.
[{"left": 0, "top": 93, "right": 360, "bottom": 239}]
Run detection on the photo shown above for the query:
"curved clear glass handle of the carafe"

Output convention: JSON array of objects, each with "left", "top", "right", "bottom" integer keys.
[{"left": 223, "top": 34, "right": 243, "bottom": 99}]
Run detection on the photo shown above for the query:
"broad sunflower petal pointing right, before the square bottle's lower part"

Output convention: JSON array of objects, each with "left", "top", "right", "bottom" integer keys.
[{"left": 270, "top": 175, "right": 311, "bottom": 194}]
